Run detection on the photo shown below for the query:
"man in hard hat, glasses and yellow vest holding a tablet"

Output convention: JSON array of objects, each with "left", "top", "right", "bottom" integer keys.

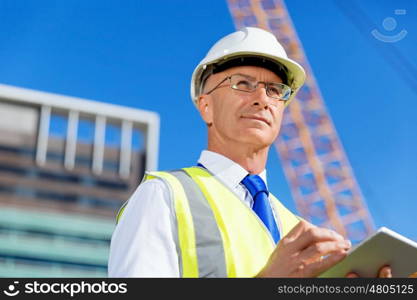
[{"left": 109, "top": 27, "right": 388, "bottom": 277}]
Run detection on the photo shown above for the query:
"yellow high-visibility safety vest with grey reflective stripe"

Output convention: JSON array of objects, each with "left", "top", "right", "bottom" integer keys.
[{"left": 117, "top": 167, "right": 299, "bottom": 277}]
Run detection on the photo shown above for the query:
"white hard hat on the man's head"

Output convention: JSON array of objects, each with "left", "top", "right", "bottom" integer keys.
[{"left": 191, "top": 27, "right": 306, "bottom": 106}]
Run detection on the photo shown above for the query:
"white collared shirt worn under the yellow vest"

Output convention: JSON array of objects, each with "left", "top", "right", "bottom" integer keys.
[{"left": 108, "top": 150, "right": 279, "bottom": 277}]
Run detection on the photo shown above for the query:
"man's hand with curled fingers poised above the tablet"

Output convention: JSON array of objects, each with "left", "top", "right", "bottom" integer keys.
[{"left": 257, "top": 220, "right": 351, "bottom": 277}]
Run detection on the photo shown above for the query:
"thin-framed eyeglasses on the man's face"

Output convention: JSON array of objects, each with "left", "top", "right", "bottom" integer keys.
[{"left": 205, "top": 74, "right": 292, "bottom": 101}]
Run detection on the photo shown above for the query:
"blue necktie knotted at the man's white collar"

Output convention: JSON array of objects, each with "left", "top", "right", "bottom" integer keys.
[{"left": 242, "top": 175, "right": 280, "bottom": 243}]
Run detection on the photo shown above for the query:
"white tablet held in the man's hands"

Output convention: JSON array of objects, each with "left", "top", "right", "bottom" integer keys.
[{"left": 319, "top": 227, "right": 417, "bottom": 278}]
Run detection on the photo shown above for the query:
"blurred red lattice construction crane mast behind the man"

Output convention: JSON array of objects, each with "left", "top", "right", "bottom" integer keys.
[{"left": 228, "top": 0, "right": 374, "bottom": 243}]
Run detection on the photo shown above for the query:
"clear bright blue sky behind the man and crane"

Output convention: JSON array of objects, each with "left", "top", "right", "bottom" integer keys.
[{"left": 0, "top": 0, "right": 417, "bottom": 240}]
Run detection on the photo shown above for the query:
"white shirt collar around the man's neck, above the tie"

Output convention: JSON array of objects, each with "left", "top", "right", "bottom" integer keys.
[{"left": 198, "top": 150, "right": 268, "bottom": 189}]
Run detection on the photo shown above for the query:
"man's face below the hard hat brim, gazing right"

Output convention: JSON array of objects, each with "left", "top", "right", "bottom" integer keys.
[{"left": 199, "top": 66, "right": 284, "bottom": 149}]
